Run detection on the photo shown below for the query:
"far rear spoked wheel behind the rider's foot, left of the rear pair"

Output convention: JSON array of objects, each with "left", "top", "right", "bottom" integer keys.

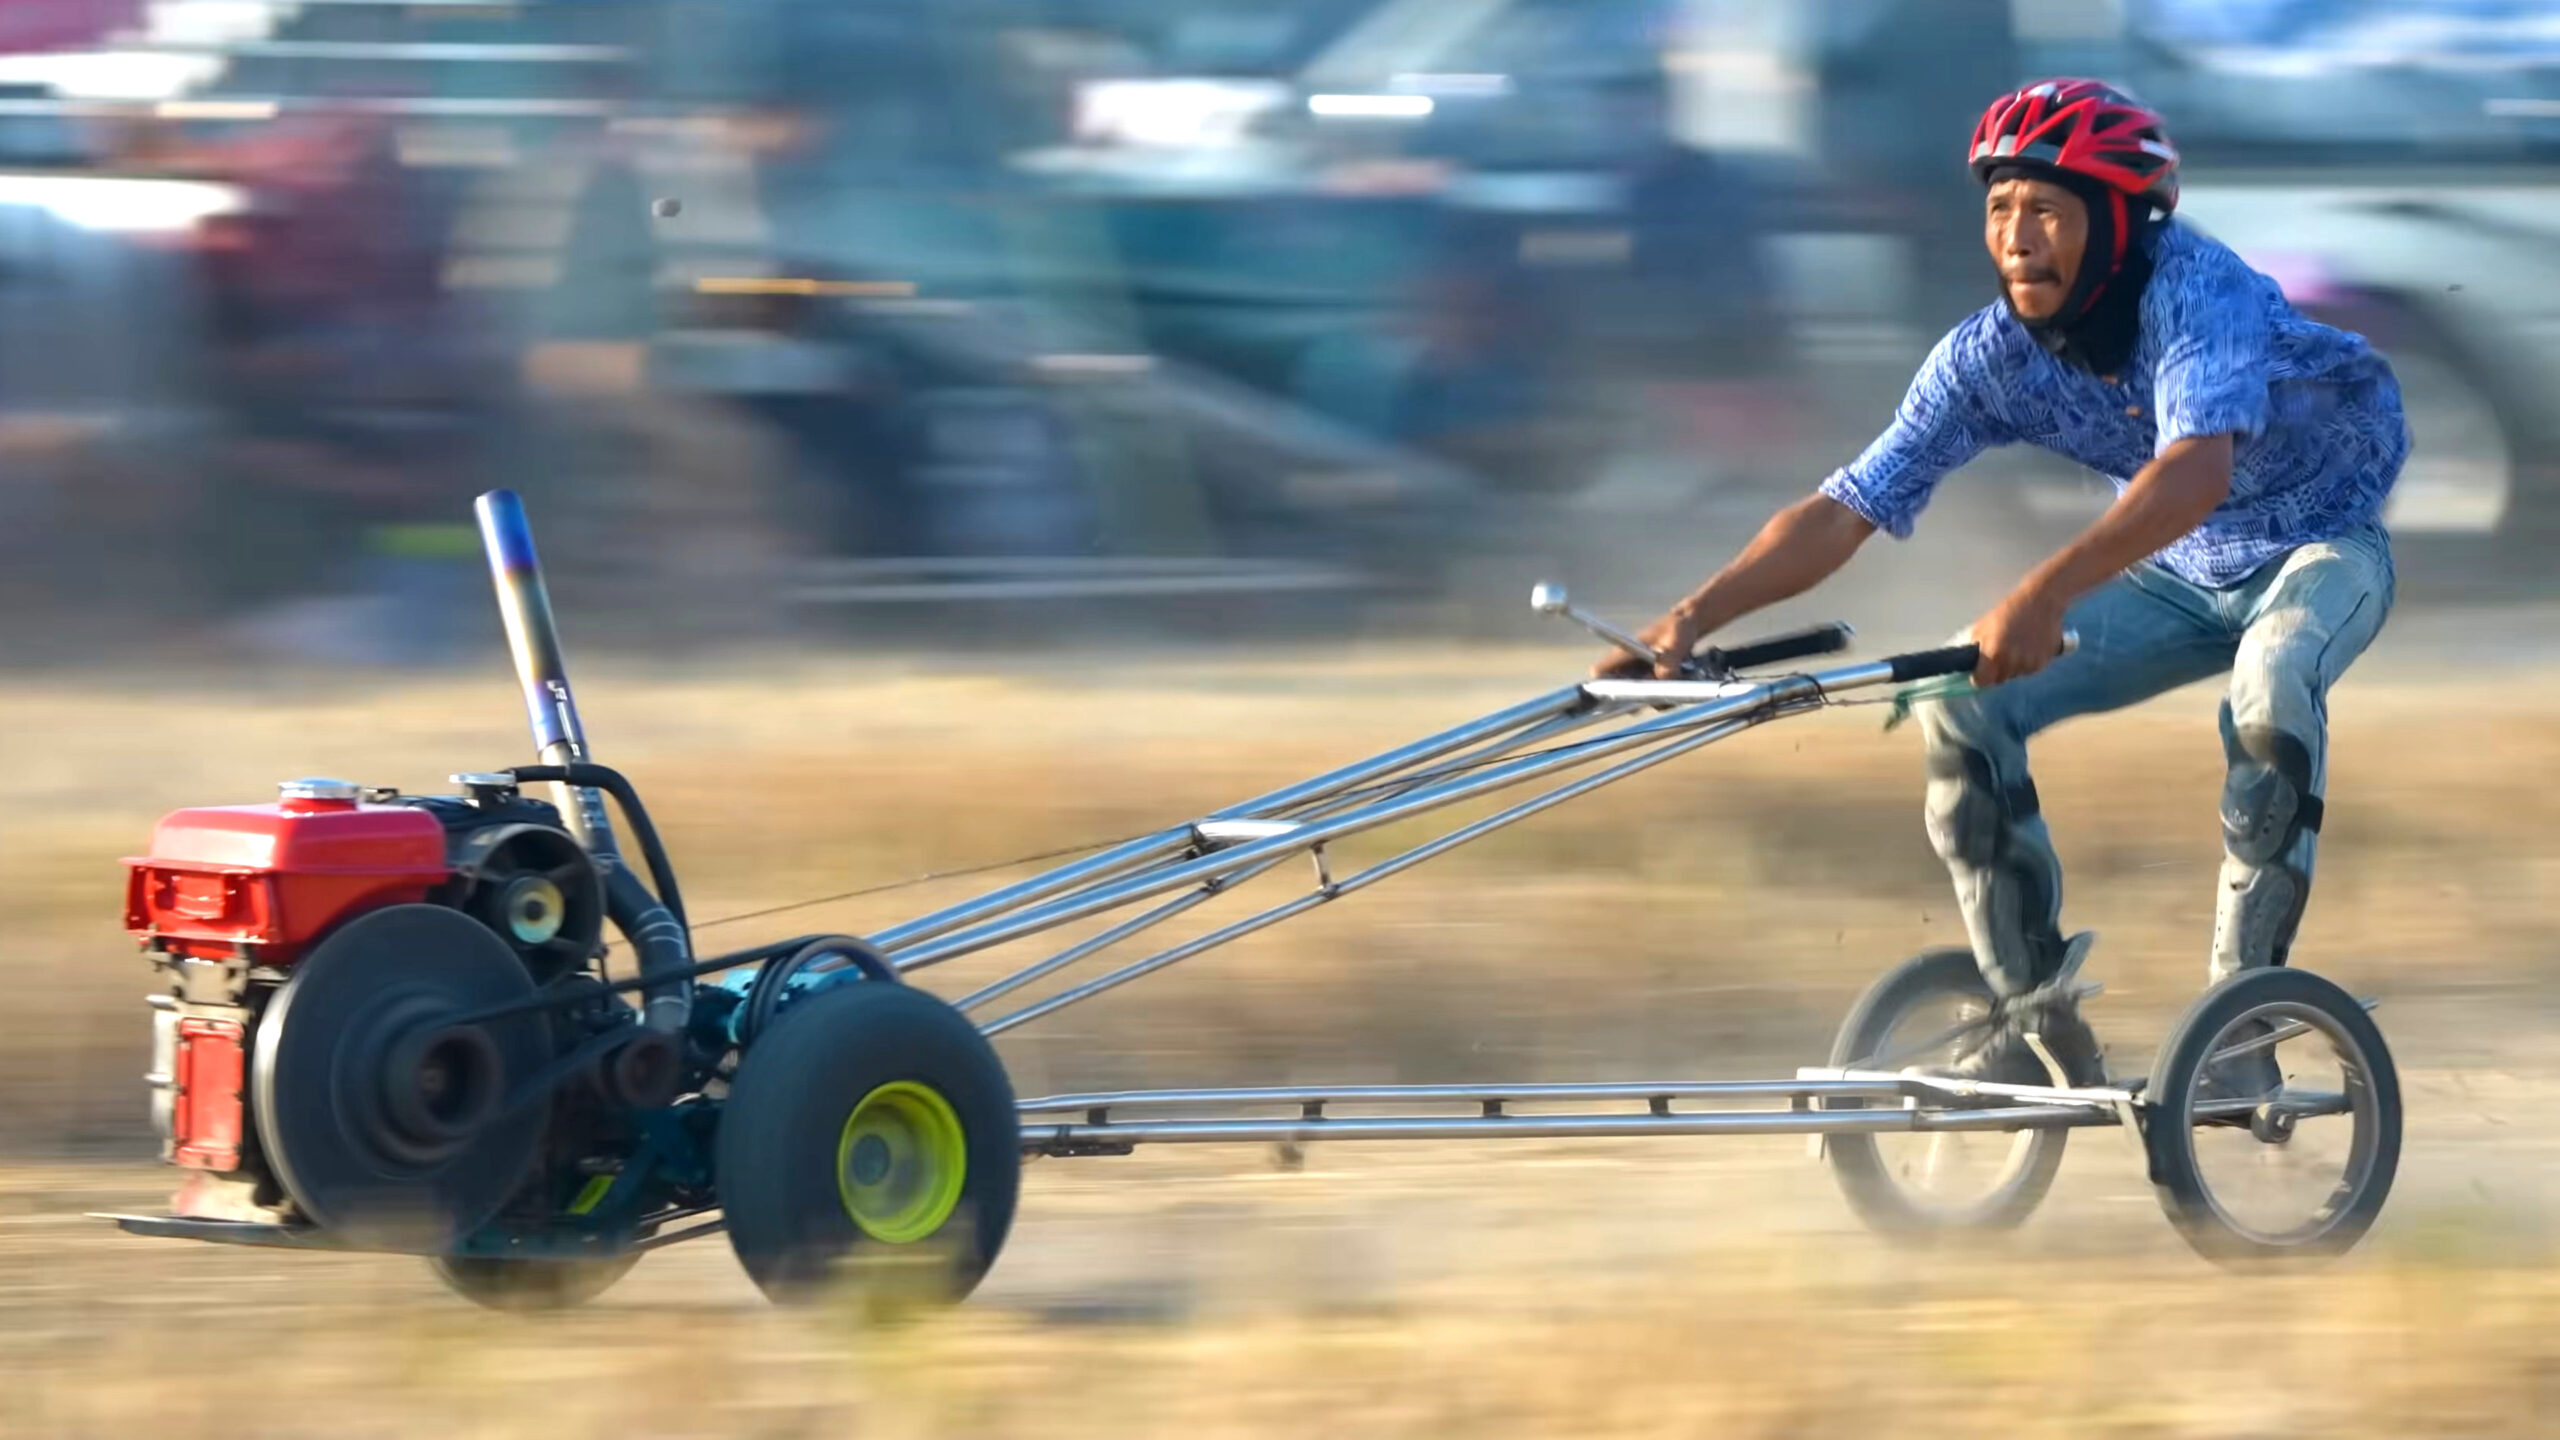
[{"left": 1823, "top": 948, "right": 2068, "bottom": 1245}]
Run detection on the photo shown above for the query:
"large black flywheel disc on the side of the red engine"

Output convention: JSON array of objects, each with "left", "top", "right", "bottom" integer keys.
[{"left": 251, "top": 904, "right": 550, "bottom": 1250}]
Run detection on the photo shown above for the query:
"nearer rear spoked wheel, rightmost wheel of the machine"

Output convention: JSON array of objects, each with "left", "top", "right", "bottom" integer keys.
[{"left": 2143, "top": 966, "right": 2401, "bottom": 1266}]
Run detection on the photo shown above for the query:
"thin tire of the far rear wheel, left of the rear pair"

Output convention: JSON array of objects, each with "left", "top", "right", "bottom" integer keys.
[{"left": 1823, "top": 948, "right": 2071, "bottom": 1245}]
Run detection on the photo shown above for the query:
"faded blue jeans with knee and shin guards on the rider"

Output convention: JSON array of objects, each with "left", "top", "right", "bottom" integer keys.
[{"left": 1920, "top": 525, "right": 2399, "bottom": 994}]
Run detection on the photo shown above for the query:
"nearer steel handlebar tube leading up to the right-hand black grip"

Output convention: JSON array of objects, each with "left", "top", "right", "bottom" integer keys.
[{"left": 901, "top": 679, "right": 1815, "bottom": 971}]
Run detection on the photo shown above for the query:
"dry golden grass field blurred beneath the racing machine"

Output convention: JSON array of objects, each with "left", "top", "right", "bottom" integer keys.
[{"left": 0, "top": 648, "right": 2560, "bottom": 1440}]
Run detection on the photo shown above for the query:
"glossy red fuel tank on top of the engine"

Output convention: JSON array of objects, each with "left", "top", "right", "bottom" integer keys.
[{"left": 125, "top": 784, "right": 451, "bottom": 966}]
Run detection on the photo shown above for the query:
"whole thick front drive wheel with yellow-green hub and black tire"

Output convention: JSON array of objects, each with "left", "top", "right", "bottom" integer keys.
[{"left": 719, "top": 981, "right": 1021, "bottom": 1314}]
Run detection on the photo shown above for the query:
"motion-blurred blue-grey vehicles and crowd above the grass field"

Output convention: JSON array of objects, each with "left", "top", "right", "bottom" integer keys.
[{"left": 0, "top": 0, "right": 2560, "bottom": 664}]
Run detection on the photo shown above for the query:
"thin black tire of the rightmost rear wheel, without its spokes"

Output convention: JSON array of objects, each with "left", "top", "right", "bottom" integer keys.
[{"left": 2143, "top": 966, "right": 2401, "bottom": 1268}]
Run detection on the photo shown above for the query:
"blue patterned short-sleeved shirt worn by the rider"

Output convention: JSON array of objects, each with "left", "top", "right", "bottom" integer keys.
[{"left": 1820, "top": 220, "right": 2409, "bottom": 589}]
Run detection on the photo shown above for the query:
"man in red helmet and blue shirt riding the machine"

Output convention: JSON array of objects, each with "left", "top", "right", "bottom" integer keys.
[{"left": 1592, "top": 79, "right": 2409, "bottom": 1094}]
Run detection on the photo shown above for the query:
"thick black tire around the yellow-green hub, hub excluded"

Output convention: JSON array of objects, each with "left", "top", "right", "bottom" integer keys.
[{"left": 717, "top": 981, "right": 1021, "bottom": 1304}]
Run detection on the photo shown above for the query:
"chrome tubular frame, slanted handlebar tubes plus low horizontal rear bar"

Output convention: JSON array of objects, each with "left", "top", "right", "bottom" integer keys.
[{"left": 844, "top": 630, "right": 2135, "bottom": 1156}]
